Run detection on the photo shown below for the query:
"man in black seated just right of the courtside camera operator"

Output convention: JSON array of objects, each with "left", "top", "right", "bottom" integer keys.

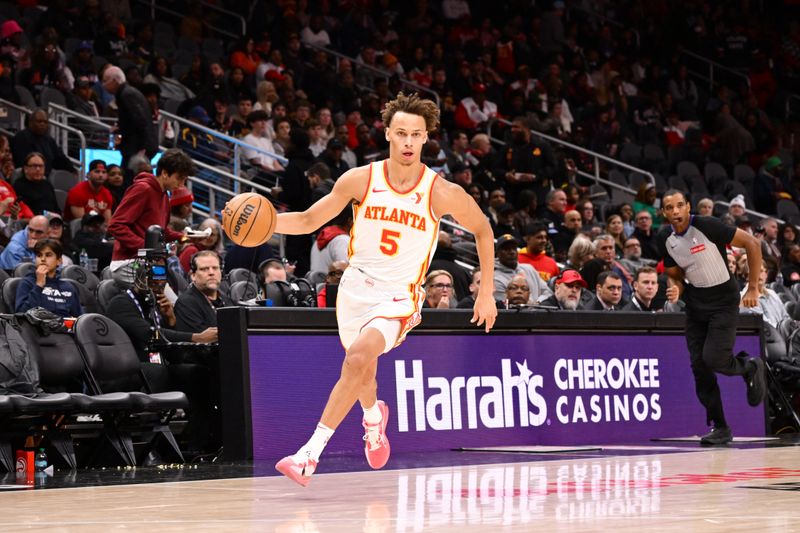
[{"left": 175, "top": 250, "right": 232, "bottom": 333}]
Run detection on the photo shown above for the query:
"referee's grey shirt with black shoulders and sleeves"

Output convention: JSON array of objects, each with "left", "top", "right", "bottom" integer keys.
[{"left": 659, "top": 215, "right": 738, "bottom": 292}]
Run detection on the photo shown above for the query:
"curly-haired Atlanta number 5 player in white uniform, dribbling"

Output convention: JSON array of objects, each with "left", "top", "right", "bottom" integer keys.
[{"left": 275, "top": 93, "right": 497, "bottom": 486}]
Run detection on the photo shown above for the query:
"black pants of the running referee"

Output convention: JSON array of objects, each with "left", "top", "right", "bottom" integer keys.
[{"left": 686, "top": 292, "right": 747, "bottom": 427}]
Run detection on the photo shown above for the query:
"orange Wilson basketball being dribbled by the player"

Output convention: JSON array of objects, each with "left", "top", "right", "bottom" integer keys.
[{"left": 222, "top": 192, "right": 278, "bottom": 247}]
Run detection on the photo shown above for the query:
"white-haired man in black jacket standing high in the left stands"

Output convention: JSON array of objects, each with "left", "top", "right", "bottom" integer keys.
[{"left": 103, "top": 66, "right": 158, "bottom": 179}]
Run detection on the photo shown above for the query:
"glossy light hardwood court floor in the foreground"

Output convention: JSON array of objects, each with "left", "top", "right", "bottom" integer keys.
[{"left": 0, "top": 445, "right": 800, "bottom": 533}]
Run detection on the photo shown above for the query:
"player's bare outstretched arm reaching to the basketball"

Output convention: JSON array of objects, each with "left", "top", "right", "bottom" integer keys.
[{"left": 275, "top": 166, "right": 369, "bottom": 235}]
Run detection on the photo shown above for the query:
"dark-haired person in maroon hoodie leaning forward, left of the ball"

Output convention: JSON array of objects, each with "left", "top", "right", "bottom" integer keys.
[{"left": 108, "top": 149, "right": 194, "bottom": 287}]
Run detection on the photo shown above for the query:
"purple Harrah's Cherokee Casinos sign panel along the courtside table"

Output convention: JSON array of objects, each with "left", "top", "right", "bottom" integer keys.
[{"left": 249, "top": 333, "right": 764, "bottom": 459}]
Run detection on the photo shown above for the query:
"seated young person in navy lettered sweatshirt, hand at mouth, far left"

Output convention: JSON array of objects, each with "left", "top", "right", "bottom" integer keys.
[{"left": 14, "top": 239, "right": 83, "bottom": 317}]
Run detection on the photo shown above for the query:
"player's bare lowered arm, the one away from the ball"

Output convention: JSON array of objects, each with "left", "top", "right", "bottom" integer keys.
[{"left": 431, "top": 179, "right": 497, "bottom": 333}]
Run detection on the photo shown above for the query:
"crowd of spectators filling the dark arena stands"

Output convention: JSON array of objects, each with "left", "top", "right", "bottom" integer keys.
[{"left": 0, "top": 0, "right": 800, "bottom": 456}]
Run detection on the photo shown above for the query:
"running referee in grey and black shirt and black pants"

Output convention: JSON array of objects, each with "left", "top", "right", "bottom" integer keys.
[{"left": 658, "top": 189, "right": 766, "bottom": 446}]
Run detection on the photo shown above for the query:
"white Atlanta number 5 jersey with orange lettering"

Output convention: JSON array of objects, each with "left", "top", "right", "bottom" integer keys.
[{"left": 348, "top": 160, "right": 439, "bottom": 286}]
